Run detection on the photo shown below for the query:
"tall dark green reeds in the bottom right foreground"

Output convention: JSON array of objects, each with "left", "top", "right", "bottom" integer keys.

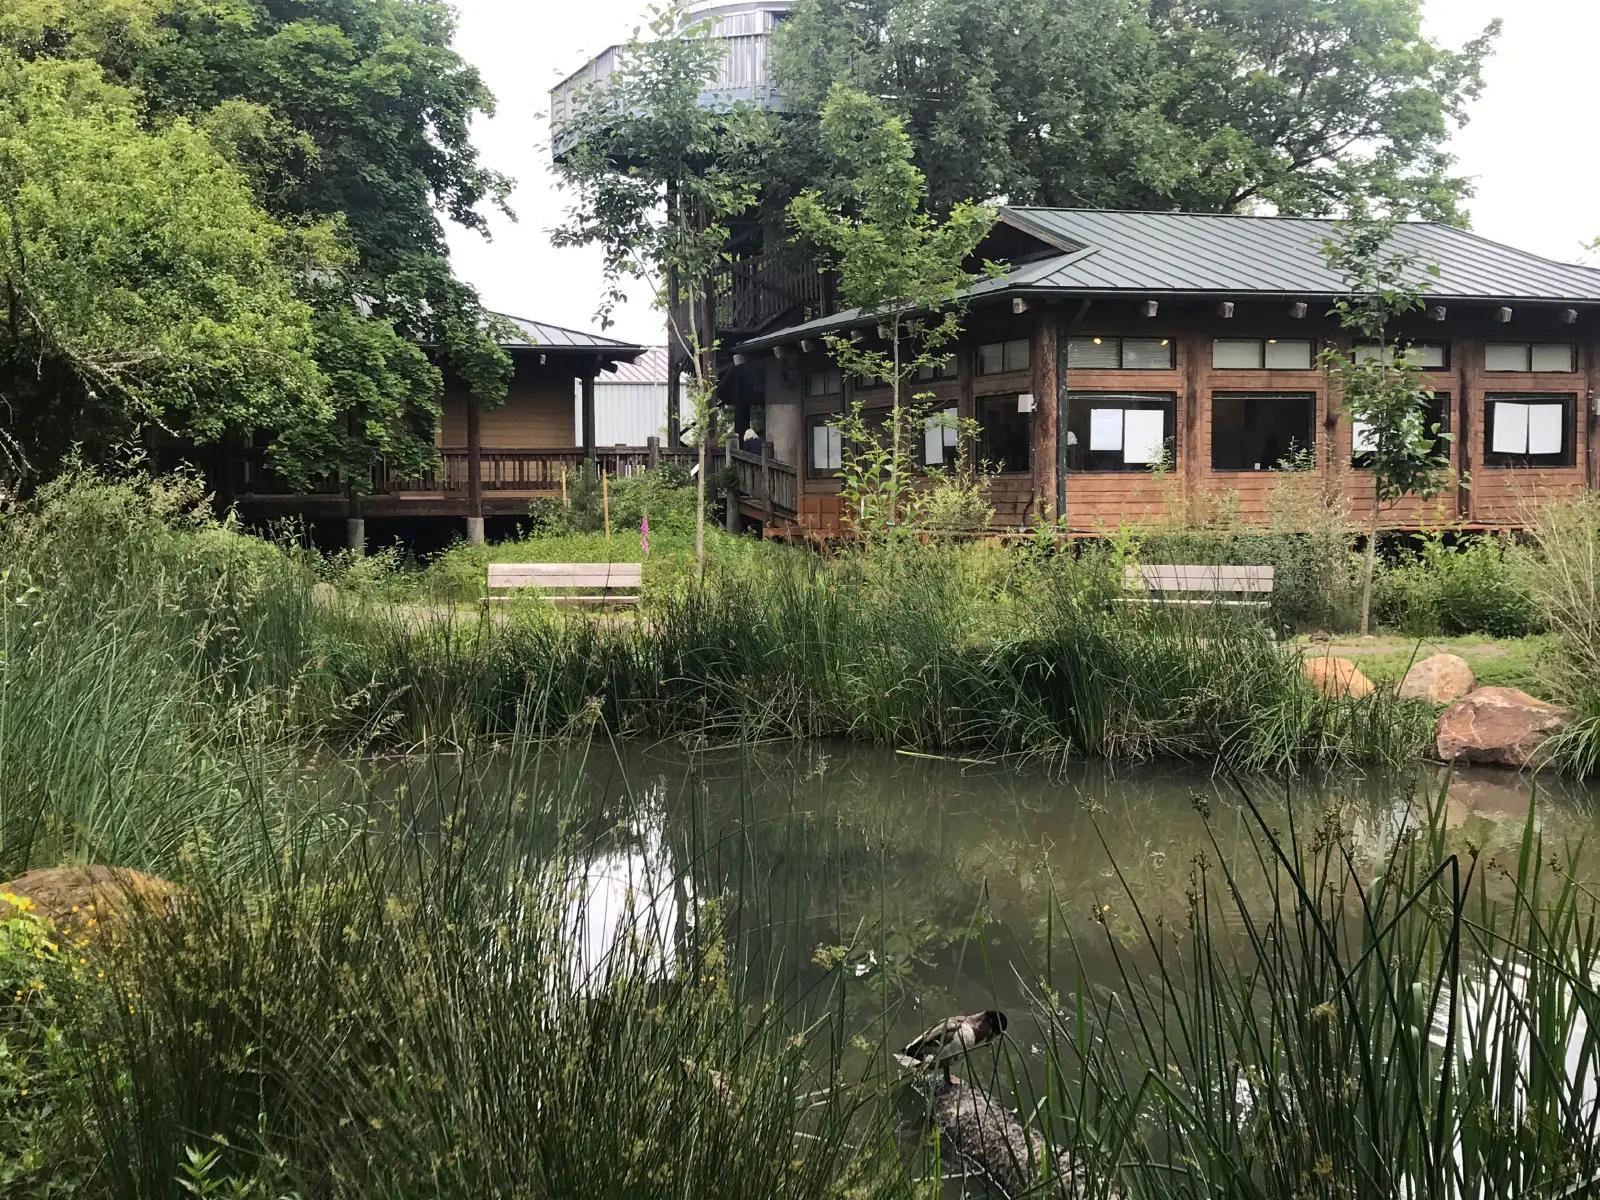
[{"left": 1042, "top": 794, "right": 1600, "bottom": 1200}]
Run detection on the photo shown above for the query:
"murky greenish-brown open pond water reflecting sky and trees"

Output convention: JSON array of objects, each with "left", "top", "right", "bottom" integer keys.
[{"left": 508, "top": 744, "right": 1600, "bottom": 1068}]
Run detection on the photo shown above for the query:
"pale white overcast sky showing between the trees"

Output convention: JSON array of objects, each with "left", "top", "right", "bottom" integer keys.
[{"left": 450, "top": 0, "right": 1600, "bottom": 342}]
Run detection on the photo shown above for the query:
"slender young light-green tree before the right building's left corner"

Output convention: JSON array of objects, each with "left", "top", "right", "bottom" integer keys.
[{"left": 789, "top": 83, "right": 995, "bottom": 526}]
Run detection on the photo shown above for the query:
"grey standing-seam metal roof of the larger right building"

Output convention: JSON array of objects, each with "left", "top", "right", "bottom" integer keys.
[{"left": 738, "top": 208, "right": 1600, "bottom": 350}]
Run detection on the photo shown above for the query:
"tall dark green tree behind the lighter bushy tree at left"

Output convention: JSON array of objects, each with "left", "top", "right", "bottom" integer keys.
[{"left": 10, "top": 0, "right": 510, "bottom": 490}]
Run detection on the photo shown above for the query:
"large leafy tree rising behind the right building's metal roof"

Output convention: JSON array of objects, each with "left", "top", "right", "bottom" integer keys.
[{"left": 774, "top": 0, "right": 1498, "bottom": 221}]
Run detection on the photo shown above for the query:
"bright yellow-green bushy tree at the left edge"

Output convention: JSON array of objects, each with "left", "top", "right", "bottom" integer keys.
[{"left": 0, "top": 50, "right": 330, "bottom": 472}]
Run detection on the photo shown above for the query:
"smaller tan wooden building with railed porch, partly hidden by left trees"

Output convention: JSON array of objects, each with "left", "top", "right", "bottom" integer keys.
[{"left": 232, "top": 317, "right": 656, "bottom": 546}]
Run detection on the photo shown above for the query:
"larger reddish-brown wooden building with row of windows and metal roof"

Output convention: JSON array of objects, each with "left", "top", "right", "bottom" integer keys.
[{"left": 736, "top": 208, "right": 1600, "bottom": 533}]
